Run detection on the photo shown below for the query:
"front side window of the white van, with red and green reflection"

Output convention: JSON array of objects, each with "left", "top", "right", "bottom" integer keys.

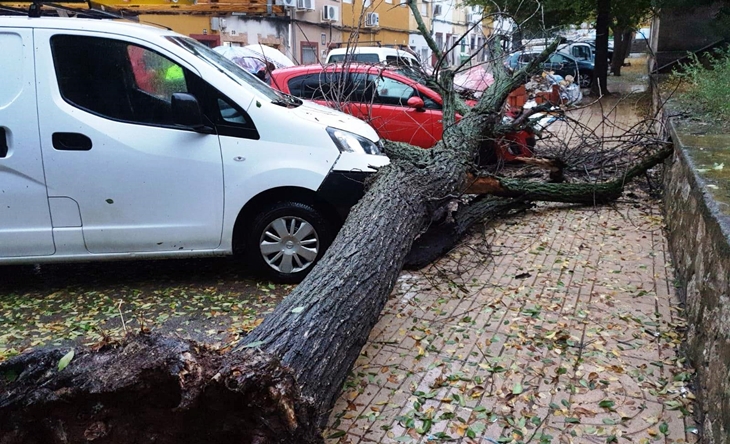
[{"left": 51, "top": 35, "right": 192, "bottom": 125}]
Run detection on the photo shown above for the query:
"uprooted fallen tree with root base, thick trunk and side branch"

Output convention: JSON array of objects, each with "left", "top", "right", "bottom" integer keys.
[{"left": 0, "top": 40, "right": 664, "bottom": 444}]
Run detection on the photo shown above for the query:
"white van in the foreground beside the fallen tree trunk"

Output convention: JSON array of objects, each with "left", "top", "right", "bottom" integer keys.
[{"left": 0, "top": 17, "right": 388, "bottom": 281}]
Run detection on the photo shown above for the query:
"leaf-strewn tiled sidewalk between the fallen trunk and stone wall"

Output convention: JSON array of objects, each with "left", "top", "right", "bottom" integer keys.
[{"left": 325, "top": 198, "right": 695, "bottom": 444}]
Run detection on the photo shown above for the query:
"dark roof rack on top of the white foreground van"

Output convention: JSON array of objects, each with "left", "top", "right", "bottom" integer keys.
[{"left": 0, "top": 0, "right": 138, "bottom": 21}]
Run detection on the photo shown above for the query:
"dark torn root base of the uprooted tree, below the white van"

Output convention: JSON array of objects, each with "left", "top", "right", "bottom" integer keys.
[{"left": 0, "top": 334, "right": 322, "bottom": 444}]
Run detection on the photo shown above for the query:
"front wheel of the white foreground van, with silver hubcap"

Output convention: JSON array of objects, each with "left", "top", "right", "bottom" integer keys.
[{"left": 245, "top": 202, "right": 336, "bottom": 283}]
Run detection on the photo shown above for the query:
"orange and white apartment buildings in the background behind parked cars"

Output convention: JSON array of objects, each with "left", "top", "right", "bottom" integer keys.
[{"left": 74, "top": 0, "right": 491, "bottom": 66}]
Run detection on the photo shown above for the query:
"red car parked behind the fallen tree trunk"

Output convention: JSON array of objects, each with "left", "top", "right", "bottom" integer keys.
[{"left": 271, "top": 64, "right": 534, "bottom": 160}]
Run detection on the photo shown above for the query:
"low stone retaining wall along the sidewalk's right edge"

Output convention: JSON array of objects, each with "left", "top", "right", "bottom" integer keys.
[{"left": 664, "top": 122, "right": 730, "bottom": 444}]
